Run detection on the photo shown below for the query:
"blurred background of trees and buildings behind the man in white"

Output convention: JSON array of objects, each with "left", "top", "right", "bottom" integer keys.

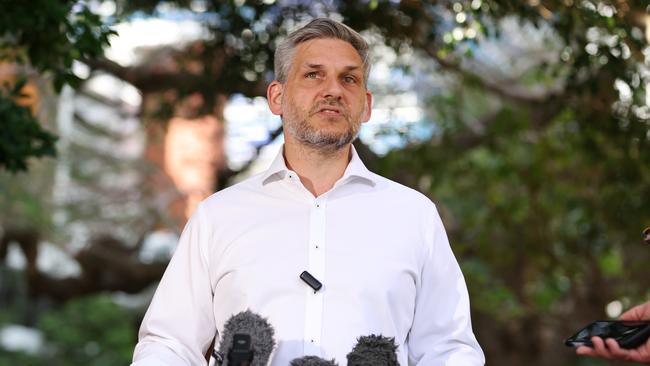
[{"left": 0, "top": 0, "right": 650, "bottom": 366}]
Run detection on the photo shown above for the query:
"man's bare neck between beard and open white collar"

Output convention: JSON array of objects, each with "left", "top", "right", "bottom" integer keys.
[{"left": 284, "top": 143, "right": 352, "bottom": 197}]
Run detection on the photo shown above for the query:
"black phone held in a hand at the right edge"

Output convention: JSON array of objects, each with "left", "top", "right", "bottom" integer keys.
[{"left": 564, "top": 320, "right": 650, "bottom": 349}]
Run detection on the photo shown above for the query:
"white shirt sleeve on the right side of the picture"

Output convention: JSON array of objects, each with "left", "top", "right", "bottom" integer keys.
[{"left": 408, "top": 207, "right": 485, "bottom": 366}]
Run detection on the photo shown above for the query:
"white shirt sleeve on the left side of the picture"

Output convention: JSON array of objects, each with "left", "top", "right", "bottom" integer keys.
[{"left": 132, "top": 205, "right": 216, "bottom": 366}]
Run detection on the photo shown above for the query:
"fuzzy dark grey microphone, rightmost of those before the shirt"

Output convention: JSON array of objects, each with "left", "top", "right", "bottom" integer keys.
[{"left": 347, "top": 334, "right": 399, "bottom": 366}]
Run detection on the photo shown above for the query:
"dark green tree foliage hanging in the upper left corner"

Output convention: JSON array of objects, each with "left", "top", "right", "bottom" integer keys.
[{"left": 0, "top": 0, "right": 114, "bottom": 172}]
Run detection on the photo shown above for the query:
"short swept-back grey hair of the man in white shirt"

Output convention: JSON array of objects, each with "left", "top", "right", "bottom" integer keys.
[{"left": 274, "top": 18, "right": 370, "bottom": 85}]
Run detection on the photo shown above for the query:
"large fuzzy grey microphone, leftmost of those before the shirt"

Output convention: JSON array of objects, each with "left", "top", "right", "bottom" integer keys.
[{"left": 214, "top": 310, "right": 275, "bottom": 366}]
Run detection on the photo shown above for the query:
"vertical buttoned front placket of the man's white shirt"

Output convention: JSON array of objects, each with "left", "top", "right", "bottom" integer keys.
[{"left": 303, "top": 196, "right": 327, "bottom": 356}]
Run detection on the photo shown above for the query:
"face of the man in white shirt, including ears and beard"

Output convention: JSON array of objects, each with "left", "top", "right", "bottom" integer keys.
[{"left": 268, "top": 38, "right": 372, "bottom": 153}]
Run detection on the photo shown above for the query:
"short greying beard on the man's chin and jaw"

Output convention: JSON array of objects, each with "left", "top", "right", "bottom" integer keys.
[{"left": 284, "top": 119, "right": 360, "bottom": 154}]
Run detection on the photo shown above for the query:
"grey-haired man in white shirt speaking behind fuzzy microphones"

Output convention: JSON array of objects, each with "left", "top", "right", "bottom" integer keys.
[{"left": 134, "top": 19, "right": 484, "bottom": 366}]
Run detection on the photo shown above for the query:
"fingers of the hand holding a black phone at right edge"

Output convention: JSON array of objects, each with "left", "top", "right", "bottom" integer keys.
[{"left": 576, "top": 301, "right": 650, "bottom": 364}]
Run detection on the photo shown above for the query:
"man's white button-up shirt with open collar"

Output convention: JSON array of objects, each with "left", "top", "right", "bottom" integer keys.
[{"left": 133, "top": 149, "right": 485, "bottom": 366}]
